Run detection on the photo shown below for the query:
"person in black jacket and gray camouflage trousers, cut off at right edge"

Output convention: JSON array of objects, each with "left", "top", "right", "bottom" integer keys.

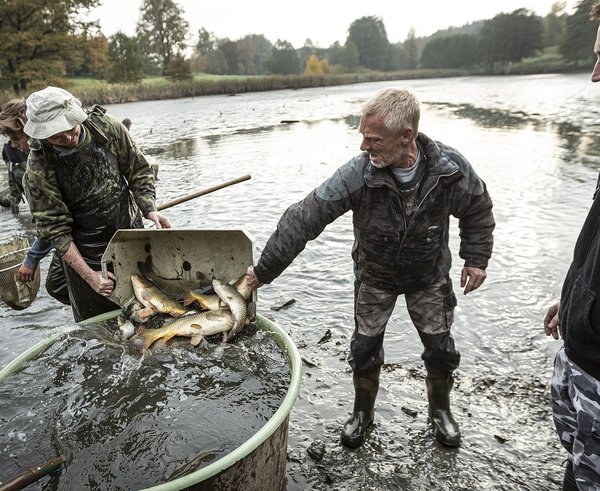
[{"left": 544, "top": 2, "right": 600, "bottom": 491}]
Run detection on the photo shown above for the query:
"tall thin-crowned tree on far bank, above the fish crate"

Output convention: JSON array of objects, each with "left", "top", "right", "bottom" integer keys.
[{"left": 136, "top": 0, "right": 189, "bottom": 72}]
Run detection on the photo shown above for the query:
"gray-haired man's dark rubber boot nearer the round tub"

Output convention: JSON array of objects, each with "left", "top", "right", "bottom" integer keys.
[{"left": 342, "top": 368, "right": 380, "bottom": 448}]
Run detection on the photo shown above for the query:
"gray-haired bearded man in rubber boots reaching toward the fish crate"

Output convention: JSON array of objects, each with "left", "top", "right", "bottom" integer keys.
[{"left": 246, "top": 88, "right": 495, "bottom": 448}]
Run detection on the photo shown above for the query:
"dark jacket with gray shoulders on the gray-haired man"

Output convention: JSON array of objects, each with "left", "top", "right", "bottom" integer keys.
[{"left": 254, "top": 133, "right": 495, "bottom": 294}]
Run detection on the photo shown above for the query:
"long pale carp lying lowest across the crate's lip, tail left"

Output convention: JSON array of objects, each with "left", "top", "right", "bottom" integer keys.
[{"left": 129, "top": 310, "right": 234, "bottom": 351}]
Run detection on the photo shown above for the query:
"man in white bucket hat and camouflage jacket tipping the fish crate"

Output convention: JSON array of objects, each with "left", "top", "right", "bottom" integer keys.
[{"left": 24, "top": 87, "right": 170, "bottom": 322}]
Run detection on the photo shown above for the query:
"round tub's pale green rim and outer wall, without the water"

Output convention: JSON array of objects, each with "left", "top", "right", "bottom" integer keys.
[{"left": 0, "top": 310, "right": 302, "bottom": 491}]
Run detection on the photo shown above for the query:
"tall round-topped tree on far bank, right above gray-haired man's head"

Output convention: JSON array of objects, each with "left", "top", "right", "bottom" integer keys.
[{"left": 346, "top": 16, "right": 390, "bottom": 70}]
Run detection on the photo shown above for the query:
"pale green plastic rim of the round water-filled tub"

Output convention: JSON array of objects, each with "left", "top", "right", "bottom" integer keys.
[{"left": 0, "top": 310, "right": 302, "bottom": 491}]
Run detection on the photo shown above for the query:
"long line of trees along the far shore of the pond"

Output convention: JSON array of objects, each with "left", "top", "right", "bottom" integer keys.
[{"left": 0, "top": 0, "right": 596, "bottom": 94}]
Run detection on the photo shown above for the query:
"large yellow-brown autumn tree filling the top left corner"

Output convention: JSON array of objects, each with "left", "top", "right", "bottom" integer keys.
[{"left": 0, "top": 0, "right": 100, "bottom": 93}]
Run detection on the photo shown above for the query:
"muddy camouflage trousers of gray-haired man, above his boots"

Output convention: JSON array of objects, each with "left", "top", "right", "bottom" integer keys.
[{"left": 348, "top": 277, "right": 460, "bottom": 374}]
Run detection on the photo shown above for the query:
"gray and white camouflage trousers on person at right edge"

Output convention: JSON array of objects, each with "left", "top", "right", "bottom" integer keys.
[{"left": 551, "top": 348, "right": 600, "bottom": 491}]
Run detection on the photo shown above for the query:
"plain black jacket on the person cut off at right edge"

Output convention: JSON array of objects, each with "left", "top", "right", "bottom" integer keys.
[{"left": 560, "top": 177, "right": 600, "bottom": 380}]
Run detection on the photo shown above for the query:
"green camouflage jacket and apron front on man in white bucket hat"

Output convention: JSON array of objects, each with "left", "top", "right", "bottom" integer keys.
[{"left": 24, "top": 106, "right": 156, "bottom": 260}]
